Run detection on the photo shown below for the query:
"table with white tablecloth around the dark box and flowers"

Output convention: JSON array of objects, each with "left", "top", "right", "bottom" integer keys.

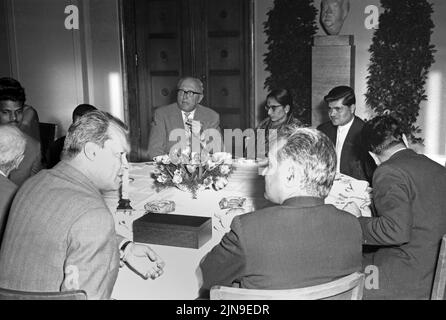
[{"left": 105, "top": 163, "right": 370, "bottom": 300}]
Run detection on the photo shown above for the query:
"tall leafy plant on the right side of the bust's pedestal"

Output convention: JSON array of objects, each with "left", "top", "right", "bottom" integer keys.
[{"left": 366, "top": 0, "right": 435, "bottom": 142}]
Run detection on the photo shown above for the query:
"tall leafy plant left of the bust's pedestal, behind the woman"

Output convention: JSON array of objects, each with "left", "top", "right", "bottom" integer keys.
[{"left": 264, "top": 0, "right": 317, "bottom": 124}]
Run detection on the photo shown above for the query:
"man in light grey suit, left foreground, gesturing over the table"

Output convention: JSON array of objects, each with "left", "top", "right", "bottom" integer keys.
[{"left": 0, "top": 111, "right": 164, "bottom": 299}]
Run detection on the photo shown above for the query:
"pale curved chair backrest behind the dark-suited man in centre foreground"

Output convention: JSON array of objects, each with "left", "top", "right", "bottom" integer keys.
[{"left": 211, "top": 272, "right": 364, "bottom": 300}]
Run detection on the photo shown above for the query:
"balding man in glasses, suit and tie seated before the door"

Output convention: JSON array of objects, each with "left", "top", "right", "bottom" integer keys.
[{"left": 148, "top": 77, "right": 220, "bottom": 160}]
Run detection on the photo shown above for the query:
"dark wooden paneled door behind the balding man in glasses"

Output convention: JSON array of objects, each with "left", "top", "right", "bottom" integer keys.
[{"left": 121, "top": 0, "right": 254, "bottom": 161}]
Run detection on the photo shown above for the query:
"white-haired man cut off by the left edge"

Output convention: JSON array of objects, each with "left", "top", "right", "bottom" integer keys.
[{"left": 0, "top": 125, "right": 26, "bottom": 245}]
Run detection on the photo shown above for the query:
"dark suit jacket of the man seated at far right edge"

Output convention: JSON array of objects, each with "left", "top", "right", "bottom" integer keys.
[{"left": 360, "top": 149, "right": 446, "bottom": 299}]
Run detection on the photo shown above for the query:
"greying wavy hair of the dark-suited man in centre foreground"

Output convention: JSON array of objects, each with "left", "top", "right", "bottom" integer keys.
[{"left": 277, "top": 125, "right": 336, "bottom": 198}]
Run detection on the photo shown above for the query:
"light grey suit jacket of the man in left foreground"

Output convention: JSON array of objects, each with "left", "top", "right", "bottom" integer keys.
[{"left": 0, "top": 161, "right": 119, "bottom": 299}]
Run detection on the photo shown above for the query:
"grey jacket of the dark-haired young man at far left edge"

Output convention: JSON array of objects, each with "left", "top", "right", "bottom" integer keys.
[{"left": 9, "top": 133, "right": 42, "bottom": 187}]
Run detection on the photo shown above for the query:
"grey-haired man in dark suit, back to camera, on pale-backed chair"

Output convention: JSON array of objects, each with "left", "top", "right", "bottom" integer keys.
[{"left": 198, "top": 126, "right": 362, "bottom": 297}]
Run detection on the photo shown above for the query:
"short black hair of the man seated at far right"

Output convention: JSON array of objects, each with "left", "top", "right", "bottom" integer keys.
[{"left": 361, "top": 115, "right": 404, "bottom": 155}]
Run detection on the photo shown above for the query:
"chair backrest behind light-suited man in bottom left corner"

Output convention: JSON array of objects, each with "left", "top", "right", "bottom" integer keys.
[{"left": 0, "top": 288, "right": 87, "bottom": 300}]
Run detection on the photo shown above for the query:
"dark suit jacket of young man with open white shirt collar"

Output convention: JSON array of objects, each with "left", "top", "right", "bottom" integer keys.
[{"left": 317, "top": 117, "right": 376, "bottom": 183}]
